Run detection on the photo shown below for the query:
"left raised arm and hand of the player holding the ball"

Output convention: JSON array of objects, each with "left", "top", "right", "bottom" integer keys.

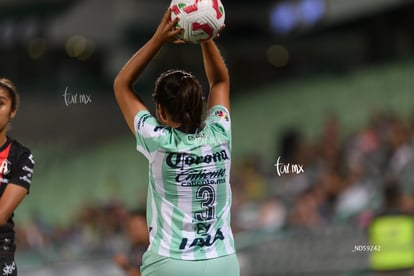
[{"left": 114, "top": 9, "right": 181, "bottom": 133}]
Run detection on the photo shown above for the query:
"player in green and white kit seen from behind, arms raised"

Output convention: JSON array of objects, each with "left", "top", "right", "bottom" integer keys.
[{"left": 114, "top": 10, "right": 239, "bottom": 276}]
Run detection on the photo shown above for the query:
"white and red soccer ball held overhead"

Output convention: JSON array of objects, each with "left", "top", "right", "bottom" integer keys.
[{"left": 170, "top": 0, "right": 225, "bottom": 43}]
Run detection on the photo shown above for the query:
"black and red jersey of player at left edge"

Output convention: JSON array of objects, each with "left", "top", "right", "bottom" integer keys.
[{"left": 0, "top": 137, "right": 35, "bottom": 237}]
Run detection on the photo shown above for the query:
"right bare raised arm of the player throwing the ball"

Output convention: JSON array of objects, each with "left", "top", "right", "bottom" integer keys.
[{"left": 201, "top": 39, "right": 230, "bottom": 110}]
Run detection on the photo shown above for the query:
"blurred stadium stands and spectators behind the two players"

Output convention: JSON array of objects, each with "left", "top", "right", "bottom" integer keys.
[{"left": 0, "top": 0, "right": 414, "bottom": 275}]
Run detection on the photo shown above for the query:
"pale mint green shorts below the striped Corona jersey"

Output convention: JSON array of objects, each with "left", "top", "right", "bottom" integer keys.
[{"left": 141, "top": 251, "right": 240, "bottom": 276}]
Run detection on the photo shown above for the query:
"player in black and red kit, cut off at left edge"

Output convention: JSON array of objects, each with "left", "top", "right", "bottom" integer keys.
[{"left": 0, "top": 78, "right": 34, "bottom": 276}]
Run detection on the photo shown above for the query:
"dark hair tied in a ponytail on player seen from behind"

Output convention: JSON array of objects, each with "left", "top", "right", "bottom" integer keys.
[{"left": 153, "top": 70, "right": 204, "bottom": 133}]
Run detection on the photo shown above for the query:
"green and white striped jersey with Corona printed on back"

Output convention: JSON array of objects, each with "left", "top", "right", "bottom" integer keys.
[{"left": 134, "top": 105, "right": 235, "bottom": 260}]
